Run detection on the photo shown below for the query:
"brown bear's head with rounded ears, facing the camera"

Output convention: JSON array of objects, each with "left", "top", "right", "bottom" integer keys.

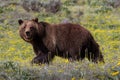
[{"left": 18, "top": 18, "right": 45, "bottom": 42}]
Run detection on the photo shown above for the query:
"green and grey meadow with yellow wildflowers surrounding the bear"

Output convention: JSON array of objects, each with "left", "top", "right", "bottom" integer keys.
[{"left": 0, "top": 0, "right": 120, "bottom": 80}]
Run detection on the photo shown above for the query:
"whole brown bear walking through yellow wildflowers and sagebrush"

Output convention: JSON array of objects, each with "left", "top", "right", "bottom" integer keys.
[{"left": 18, "top": 18, "right": 104, "bottom": 64}]
